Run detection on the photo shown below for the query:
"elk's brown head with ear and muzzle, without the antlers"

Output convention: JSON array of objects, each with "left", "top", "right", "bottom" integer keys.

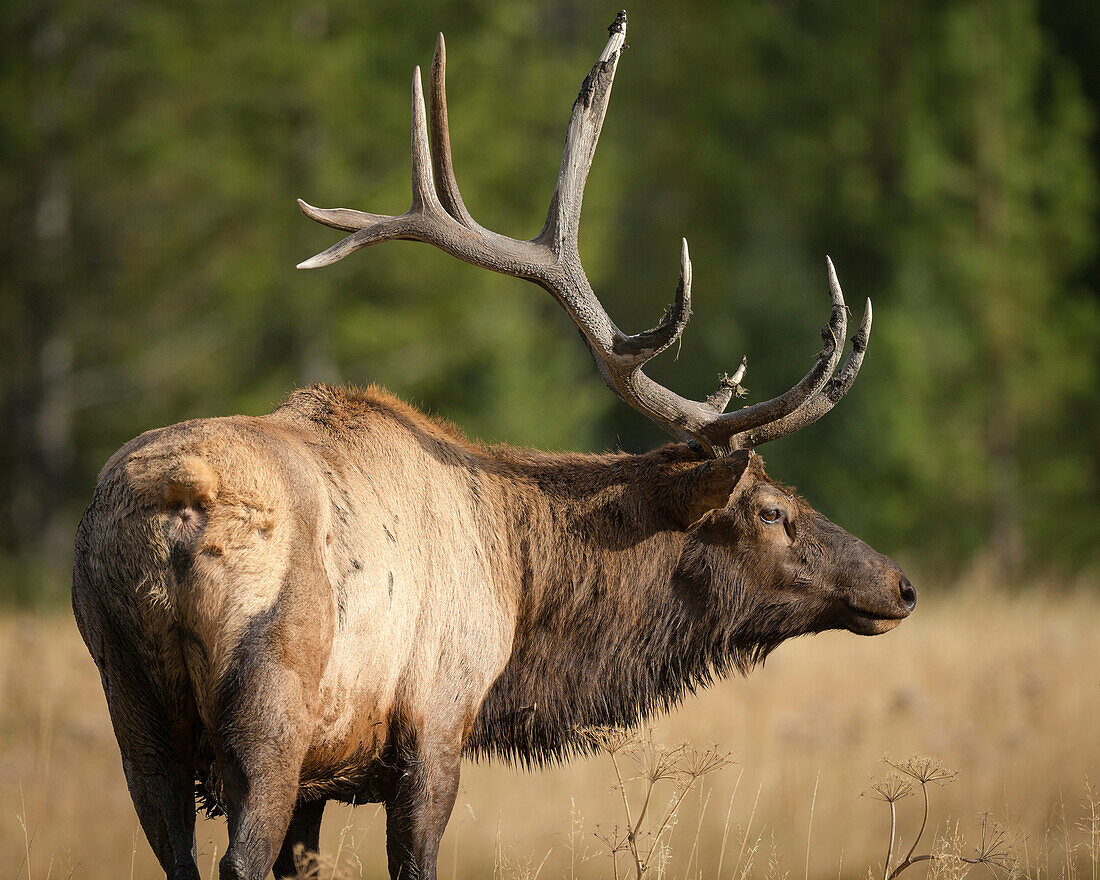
[{"left": 673, "top": 450, "right": 916, "bottom": 652}]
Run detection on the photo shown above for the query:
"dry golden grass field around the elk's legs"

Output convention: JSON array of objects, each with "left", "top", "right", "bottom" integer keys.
[{"left": 0, "top": 587, "right": 1100, "bottom": 880}]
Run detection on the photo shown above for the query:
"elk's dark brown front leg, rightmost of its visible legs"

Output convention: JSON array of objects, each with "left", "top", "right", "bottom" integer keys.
[{"left": 386, "top": 733, "right": 462, "bottom": 880}]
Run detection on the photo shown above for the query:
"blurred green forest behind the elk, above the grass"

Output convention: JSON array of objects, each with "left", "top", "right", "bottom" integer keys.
[{"left": 0, "top": 0, "right": 1100, "bottom": 605}]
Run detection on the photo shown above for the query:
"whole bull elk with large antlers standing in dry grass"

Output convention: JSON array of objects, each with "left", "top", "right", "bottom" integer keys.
[{"left": 73, "top": 13, "right": 916, "bottom": 880}]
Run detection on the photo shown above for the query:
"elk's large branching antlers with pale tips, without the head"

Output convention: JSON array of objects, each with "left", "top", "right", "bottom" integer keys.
[{"left": 298, "top": 12, "right": 871, "bottom": 455}]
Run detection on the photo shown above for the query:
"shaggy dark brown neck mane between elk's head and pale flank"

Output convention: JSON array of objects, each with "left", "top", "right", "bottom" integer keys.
[{"left": 468, "top": 444, "right": 772, "bottom": 765}]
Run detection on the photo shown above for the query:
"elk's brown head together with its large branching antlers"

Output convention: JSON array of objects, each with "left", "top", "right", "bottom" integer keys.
[{"left": 298, "top": 12, "right": 916, "bottom": 640}]
